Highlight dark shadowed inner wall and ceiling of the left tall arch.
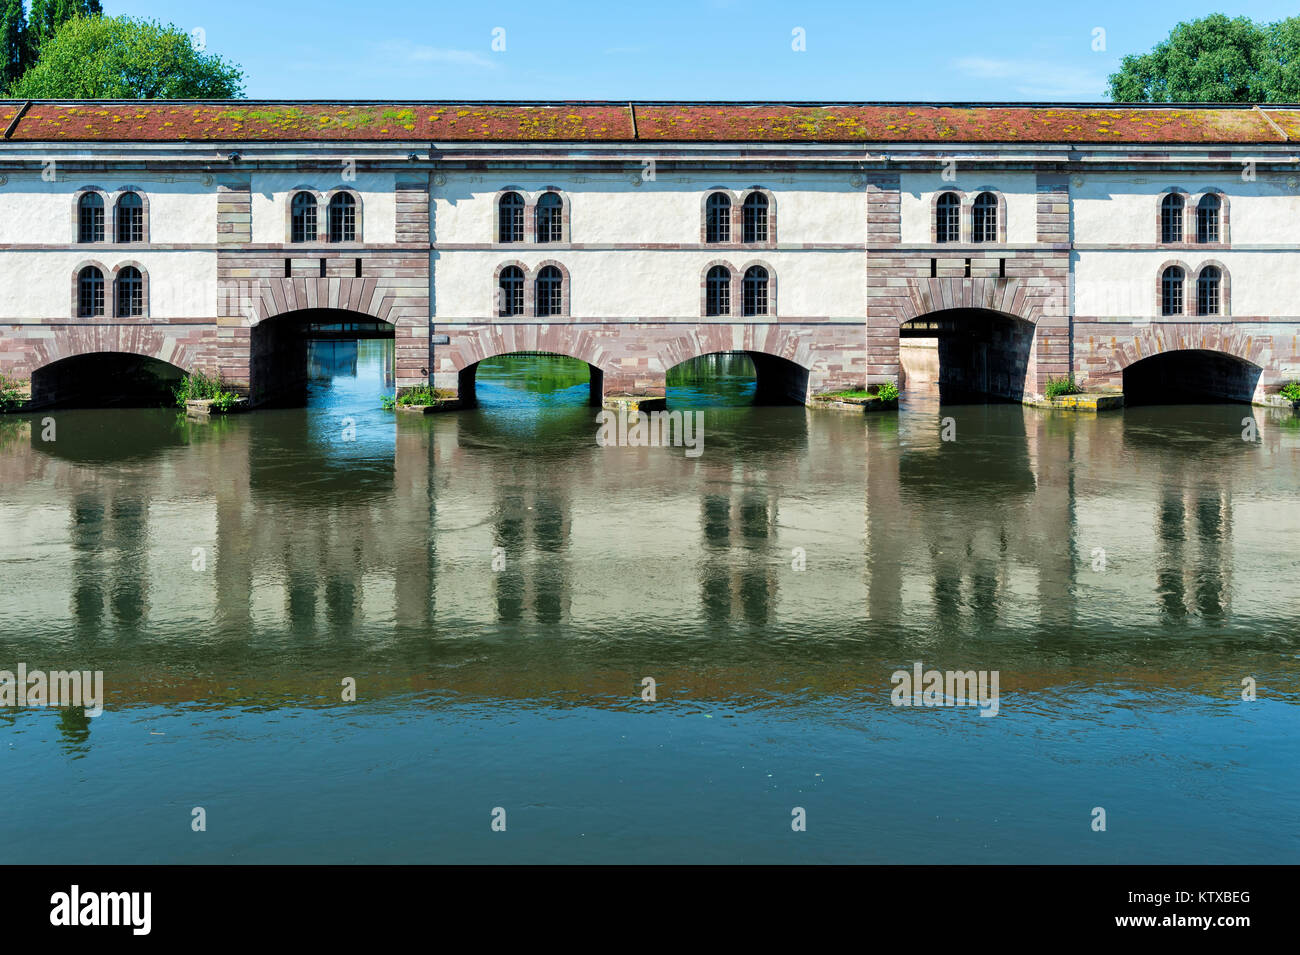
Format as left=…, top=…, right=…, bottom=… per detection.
left=248, top=308, right=397, bottom=405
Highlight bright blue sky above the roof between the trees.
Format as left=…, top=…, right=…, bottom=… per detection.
left=104, top=0, right=1300, bottom=101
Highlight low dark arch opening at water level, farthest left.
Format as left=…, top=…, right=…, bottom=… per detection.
left=30, top=351, right=185, bottom=408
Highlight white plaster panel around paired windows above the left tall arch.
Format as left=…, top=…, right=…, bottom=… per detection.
left=248, top=168, right=395, bottom=244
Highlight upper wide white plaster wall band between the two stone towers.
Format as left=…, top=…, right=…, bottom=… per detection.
left=431, top=170, right=867, bottom=246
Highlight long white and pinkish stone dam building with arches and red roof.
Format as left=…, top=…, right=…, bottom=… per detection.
left=0, top=100, right=1300, bottom=407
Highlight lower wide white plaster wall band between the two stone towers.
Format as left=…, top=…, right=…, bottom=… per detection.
left=434, top=248, right=866, bottom=321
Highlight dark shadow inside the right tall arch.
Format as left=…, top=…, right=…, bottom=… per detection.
left=898, top=308, right=1036, bottom=404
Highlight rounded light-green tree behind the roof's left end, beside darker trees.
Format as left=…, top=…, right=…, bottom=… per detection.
left=10, top=17, right=243, bottom=100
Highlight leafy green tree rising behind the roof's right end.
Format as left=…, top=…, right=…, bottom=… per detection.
left=1110, top=13, right=1300, bottom=103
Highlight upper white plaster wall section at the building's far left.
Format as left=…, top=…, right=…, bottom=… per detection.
left=0, top=173, right=217, bottom=248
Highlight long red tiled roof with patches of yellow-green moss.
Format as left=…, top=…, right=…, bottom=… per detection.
left=0, top=100, right=1300, bottom=144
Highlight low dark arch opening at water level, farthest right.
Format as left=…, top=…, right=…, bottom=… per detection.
left=1123, top=348, right=1264, bottom=404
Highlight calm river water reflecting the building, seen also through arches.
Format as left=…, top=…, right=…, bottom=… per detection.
left=0, top=342, right=1300, bottom=863
